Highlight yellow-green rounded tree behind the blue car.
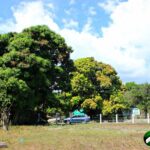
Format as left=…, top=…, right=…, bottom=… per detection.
left=71, top=57, right=122, bottom=115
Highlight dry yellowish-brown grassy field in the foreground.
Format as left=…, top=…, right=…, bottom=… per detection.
left=0, top=123, right=150, bottom=150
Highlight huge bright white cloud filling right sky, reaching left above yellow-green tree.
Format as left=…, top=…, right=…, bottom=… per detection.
left=62, top=0, right=150, bottom=82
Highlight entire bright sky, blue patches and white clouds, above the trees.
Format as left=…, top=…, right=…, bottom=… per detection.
left=0, top=0, right=150, bottom=83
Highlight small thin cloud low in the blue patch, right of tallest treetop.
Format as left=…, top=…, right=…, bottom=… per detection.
left=62, top=19, right=79, bottom=29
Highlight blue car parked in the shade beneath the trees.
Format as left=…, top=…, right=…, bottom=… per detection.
left=64, top=115, right=90, bottom=124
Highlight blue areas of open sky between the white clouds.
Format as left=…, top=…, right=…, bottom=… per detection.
left=0, top=0, right=110, bottom=34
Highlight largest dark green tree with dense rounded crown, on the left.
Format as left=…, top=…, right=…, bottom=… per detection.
left=0, top=26, right=73, bottom=124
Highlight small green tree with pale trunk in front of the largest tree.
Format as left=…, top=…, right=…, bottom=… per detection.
left=0, top=77, right=29, bottom=130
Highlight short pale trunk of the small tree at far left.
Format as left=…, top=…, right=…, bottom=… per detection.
left=2, top=111, right=9, bottom=130
